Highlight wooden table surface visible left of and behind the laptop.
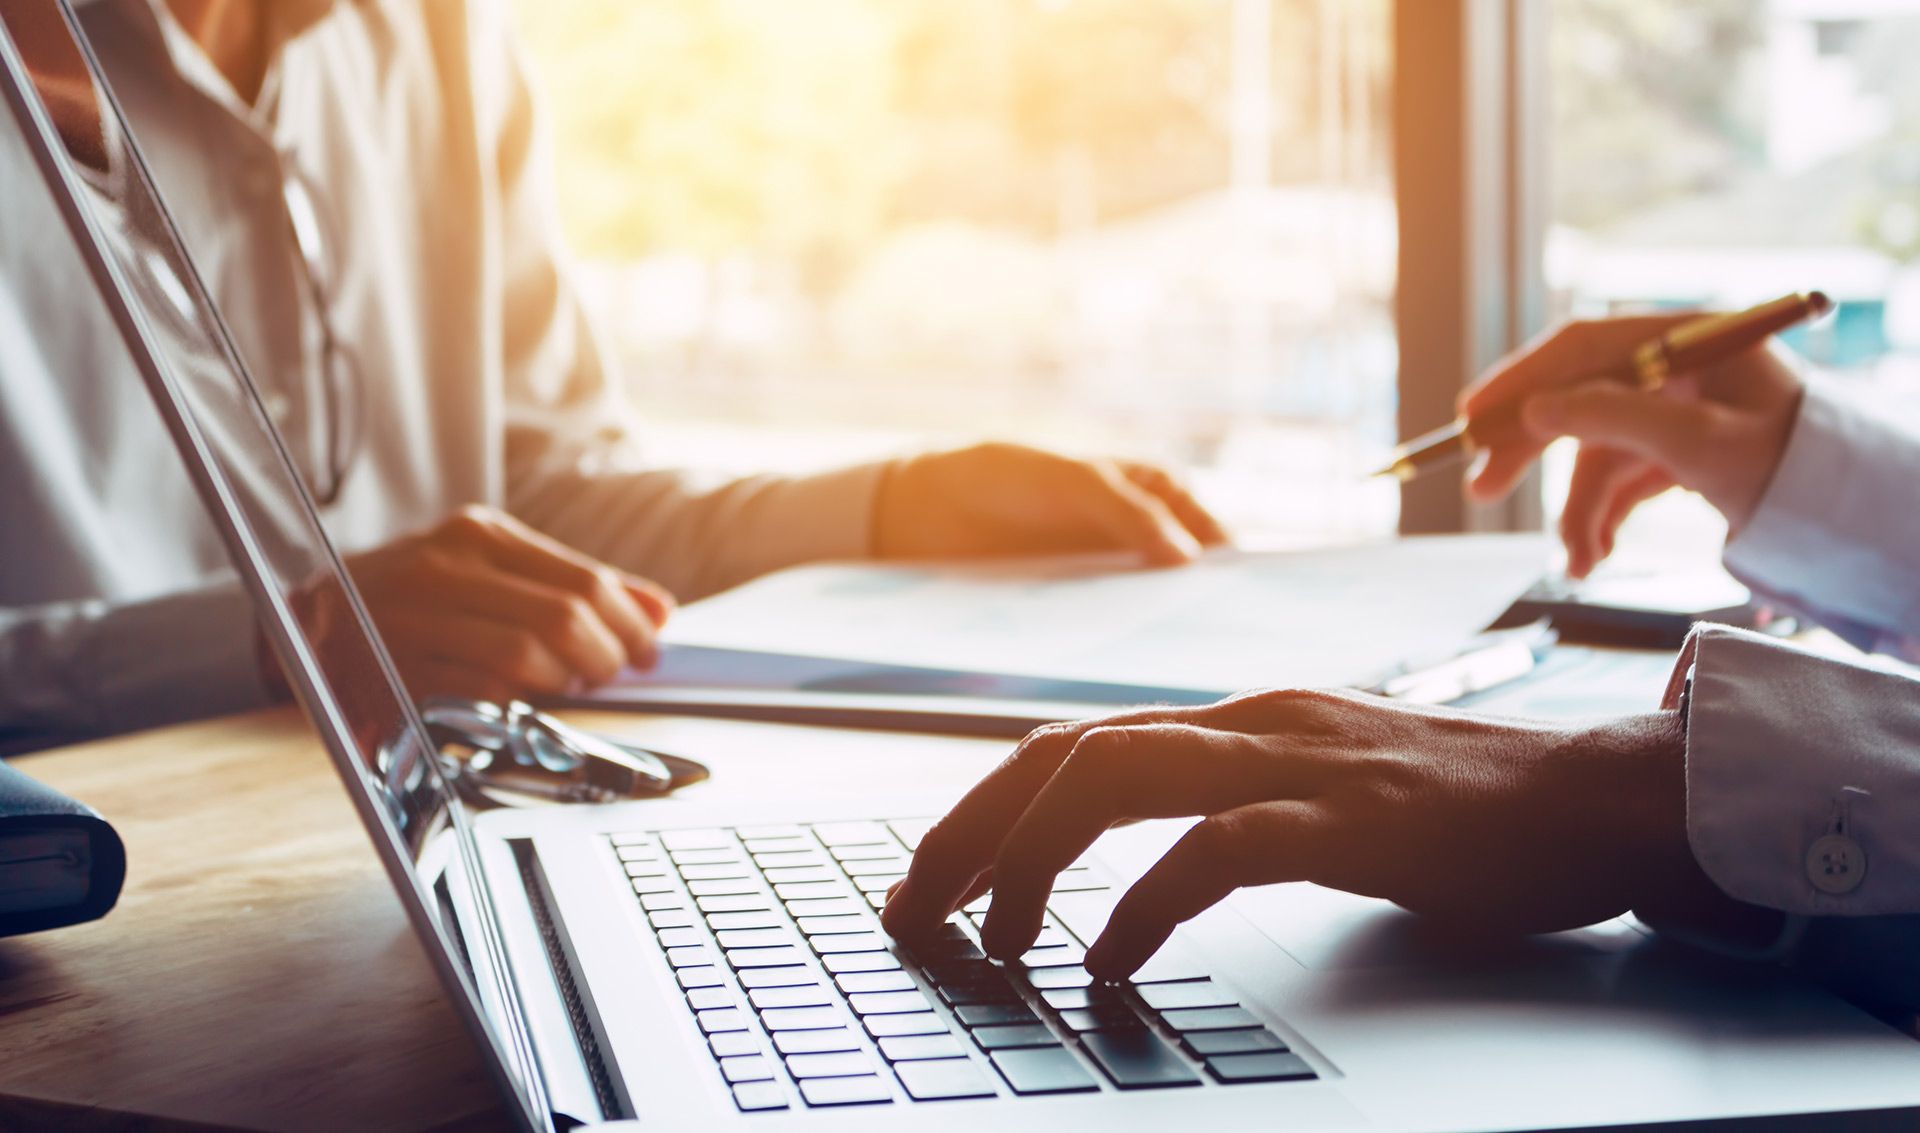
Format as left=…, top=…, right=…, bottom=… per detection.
left=0, top=709, right=1006, bottom=1129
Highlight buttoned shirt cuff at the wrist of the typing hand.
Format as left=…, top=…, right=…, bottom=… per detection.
left=1670, top=626, right=1920, bottom=916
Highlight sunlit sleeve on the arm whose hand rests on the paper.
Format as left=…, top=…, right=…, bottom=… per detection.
left=480, top=8, right=885, bottom=599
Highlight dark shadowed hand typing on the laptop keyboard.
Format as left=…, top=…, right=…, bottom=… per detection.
left=883, top=691, right=1724, bottom=979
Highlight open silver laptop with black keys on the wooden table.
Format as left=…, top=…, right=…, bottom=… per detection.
left=11, top=4, right=1920, bottom=1133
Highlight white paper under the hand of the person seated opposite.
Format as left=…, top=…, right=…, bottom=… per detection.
left=641, top=536, right=1548, bottom=691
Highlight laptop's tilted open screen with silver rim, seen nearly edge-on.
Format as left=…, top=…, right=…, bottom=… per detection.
left=0, top=11, right=553, bottom=1129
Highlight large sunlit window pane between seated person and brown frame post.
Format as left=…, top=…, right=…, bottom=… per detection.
left=518, top=0, right=1398, bottom=538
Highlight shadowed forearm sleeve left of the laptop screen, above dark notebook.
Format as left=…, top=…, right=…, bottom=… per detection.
left=0, top=582, right=271, bottom=753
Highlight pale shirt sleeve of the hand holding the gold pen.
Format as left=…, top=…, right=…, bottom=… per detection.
left=1726, top=386, right=1920, bottom=661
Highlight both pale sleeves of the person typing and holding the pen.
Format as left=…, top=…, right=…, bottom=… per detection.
left=1668, top=388, right=1920, bottom=944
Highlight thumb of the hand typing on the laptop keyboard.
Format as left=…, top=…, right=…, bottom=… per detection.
left=1085, top=799, right=1327, bottom=979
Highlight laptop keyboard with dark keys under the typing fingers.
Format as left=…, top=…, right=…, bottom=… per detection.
left=612, top=820, right=1315, bottom=1112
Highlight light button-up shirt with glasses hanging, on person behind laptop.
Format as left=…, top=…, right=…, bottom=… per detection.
left=0, top=0, right=879, bottom=751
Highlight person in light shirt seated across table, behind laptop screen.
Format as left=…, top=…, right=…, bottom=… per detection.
left=0, top=0, right=1225, bottom=764
